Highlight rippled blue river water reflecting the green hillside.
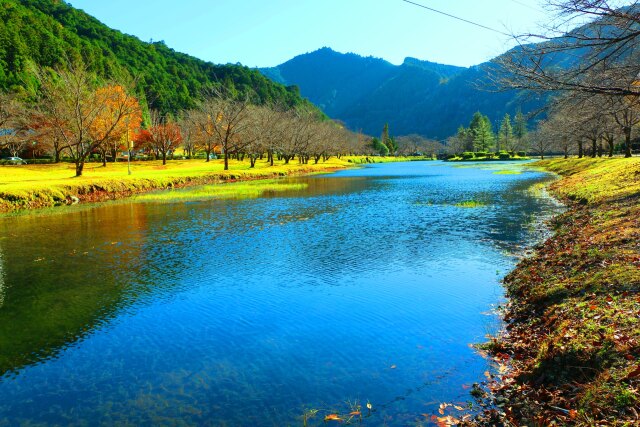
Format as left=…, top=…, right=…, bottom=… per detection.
left=0, top=162, right=555, bottom=426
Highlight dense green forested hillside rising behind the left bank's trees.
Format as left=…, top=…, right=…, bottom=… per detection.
left=0, top=0, right=306, bottom=112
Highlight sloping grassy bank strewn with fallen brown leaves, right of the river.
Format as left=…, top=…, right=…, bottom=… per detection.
left=488, top=158, right=640, bottom=426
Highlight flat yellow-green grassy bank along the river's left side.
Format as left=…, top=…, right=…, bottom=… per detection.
left=0, top=156, right=430, bottom=213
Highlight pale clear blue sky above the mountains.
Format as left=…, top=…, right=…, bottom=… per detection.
left=68, top=0, right=548, bottom=67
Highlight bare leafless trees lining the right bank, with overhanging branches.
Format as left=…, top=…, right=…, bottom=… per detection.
left=496, top=0, right=640, bottom=157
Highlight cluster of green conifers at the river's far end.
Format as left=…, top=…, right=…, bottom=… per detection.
left=447, top=111, right=528, bottom=154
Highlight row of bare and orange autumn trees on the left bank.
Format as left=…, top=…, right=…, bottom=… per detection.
left=0, top=66, right=388, bottom=176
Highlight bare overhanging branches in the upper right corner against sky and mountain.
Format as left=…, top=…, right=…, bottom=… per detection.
left=496, top=0, right=640, bottom=96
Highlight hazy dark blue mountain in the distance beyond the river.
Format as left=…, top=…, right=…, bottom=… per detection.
left=260, top=47, right=544, bottom=139
